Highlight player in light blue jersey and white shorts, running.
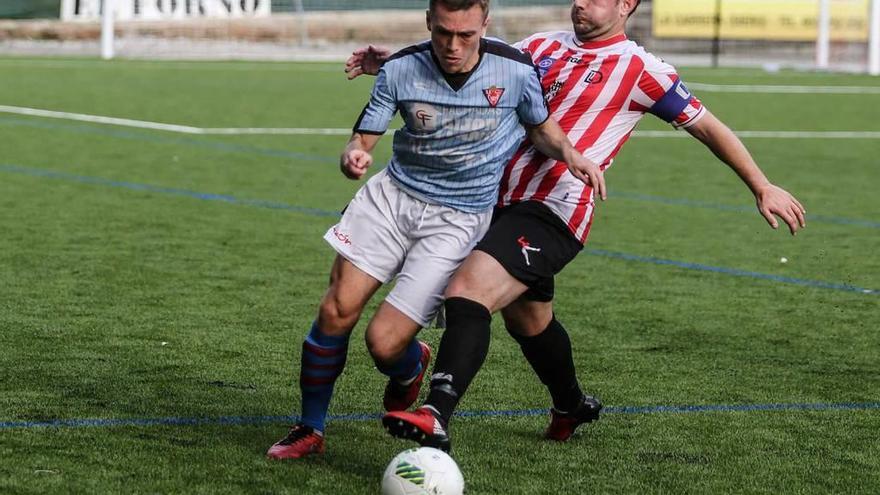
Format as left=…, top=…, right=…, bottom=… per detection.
left=267, top=0, right=605, bottom=459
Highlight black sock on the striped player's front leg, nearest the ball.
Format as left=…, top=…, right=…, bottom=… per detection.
left=425, top=297, right=492, bottom=425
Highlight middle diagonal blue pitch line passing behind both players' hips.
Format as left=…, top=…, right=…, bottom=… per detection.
left=0, top=163, right=880, bottom=295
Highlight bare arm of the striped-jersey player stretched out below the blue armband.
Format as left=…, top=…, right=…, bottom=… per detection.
left=687, top=110, right=807, bottom=235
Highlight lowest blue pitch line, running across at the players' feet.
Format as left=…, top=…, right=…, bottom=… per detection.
left=0, top=402, right=880, bottom=430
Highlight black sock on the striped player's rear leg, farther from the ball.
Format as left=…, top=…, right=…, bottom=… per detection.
left=509, top=315, right=583, bottom=412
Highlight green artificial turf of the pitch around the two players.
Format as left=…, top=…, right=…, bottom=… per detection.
left=0, top=58, right=880, bottom=494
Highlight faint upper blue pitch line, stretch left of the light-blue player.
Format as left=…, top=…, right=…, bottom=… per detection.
left=0, top=117, right=339, bottom=163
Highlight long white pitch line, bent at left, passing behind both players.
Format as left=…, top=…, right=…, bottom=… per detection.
left=0, top=105, right=880, bottom=139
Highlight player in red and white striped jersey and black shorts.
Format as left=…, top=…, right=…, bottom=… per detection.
left=346, top=0, right=805, bottom=449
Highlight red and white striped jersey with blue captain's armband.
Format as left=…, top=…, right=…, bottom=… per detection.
left=498, top=31, right=706, bottom=243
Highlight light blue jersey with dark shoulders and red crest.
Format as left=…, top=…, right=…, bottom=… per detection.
left=354, top=38, right=549, bottom=213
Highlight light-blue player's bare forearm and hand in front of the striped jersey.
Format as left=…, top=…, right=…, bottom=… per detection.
left=525, top=118, right=607, bottom=201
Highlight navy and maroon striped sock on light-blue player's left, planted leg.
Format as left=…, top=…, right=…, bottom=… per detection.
left=299, top=323, right=349, bottom=432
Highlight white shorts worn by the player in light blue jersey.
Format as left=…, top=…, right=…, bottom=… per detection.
left=324, top=170, right=492, bottom=327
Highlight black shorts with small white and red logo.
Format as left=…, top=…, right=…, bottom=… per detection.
left=474, top=201, right=584, bottom=302
